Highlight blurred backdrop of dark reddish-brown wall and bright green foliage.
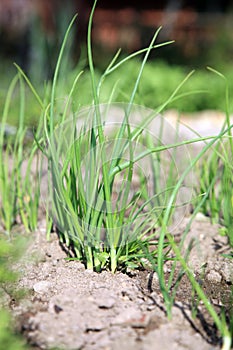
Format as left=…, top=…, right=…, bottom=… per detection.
left=0, top=0, right=233, bottom=125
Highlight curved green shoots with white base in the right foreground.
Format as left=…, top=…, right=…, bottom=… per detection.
left=154, top=116, right=233, bottom=350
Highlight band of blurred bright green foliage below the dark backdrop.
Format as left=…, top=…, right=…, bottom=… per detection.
left=0, top=56, right=233, bottom=126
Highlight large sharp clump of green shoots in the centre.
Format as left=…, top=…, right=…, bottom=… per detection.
left=37, top=2, right=200, bottom=272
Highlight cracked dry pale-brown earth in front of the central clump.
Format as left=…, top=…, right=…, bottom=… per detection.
left=8, top=216, right=233, bottom=350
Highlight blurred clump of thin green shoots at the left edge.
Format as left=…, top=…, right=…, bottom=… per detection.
left=0, top=74, right=40, bottom=234
